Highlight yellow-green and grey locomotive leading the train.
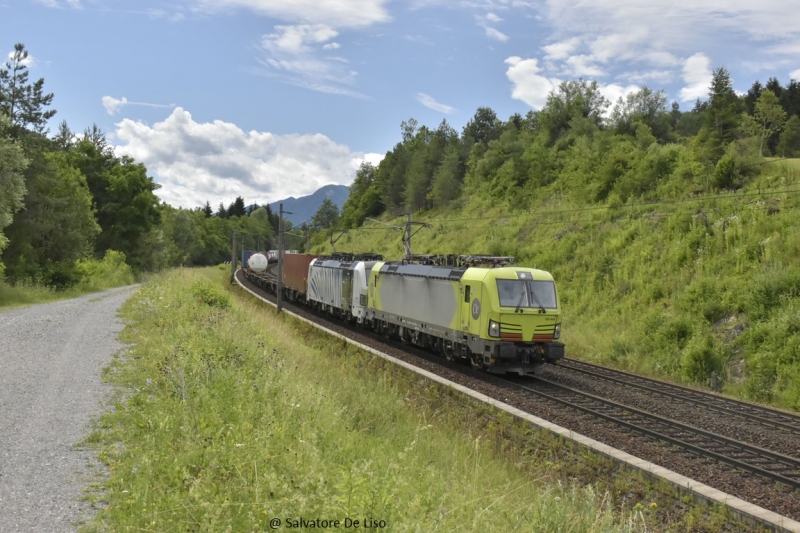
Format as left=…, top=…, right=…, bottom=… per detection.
left=367, top=256, right=564, bottom=375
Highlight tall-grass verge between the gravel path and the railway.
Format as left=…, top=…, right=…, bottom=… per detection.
left=79, top=269, right=752, bottom=532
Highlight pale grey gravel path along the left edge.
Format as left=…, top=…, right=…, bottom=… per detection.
left=0, top=286, right=136, bottom=533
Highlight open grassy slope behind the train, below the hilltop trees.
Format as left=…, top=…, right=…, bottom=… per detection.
left=314, top=160, right=800, bottom=410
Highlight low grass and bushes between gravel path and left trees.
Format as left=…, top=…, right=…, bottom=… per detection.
left=0, top=251, right=137, bottom=309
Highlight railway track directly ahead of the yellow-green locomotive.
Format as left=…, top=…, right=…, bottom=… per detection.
left=507, top=377, right=800, bottom=490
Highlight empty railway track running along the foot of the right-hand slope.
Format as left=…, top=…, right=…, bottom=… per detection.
left=559, top=359, right=800, bottom=435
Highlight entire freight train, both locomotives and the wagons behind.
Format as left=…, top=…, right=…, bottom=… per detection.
left=245, top=253, right=564, bottom=375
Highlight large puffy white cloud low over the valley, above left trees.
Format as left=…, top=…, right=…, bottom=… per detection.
left=115, top=107, right=381, bottom=207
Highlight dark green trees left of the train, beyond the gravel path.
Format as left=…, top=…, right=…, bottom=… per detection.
left=0, top=44, right=304, bottom=288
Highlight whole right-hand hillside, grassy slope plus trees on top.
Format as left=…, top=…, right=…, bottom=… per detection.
left=314, top=68, right=800, bottom=409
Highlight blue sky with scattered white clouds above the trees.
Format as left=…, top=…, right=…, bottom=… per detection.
left=0, top=0, right=800, bottom=208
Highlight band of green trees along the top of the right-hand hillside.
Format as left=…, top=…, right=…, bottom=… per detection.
left=340, top=67, right=800, bottom=227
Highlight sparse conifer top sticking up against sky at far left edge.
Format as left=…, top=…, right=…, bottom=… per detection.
left=0, top=43, right=56, bottom=133
